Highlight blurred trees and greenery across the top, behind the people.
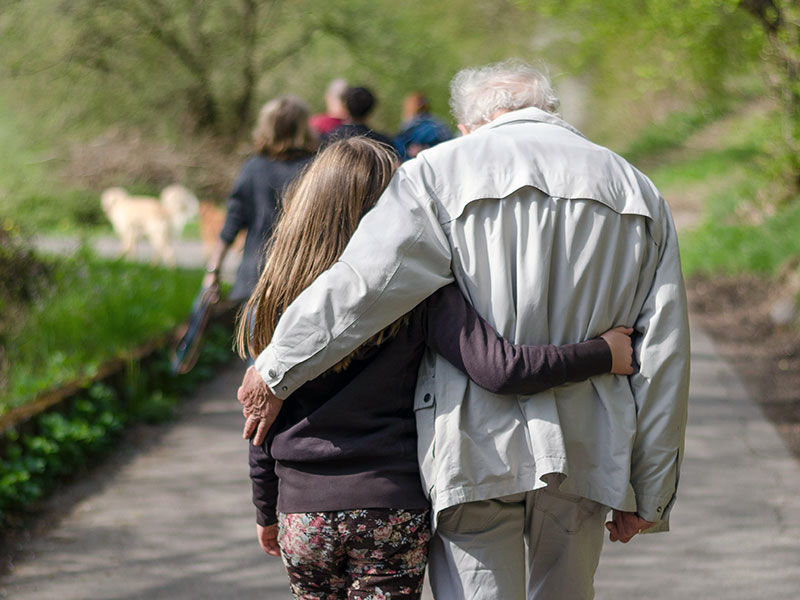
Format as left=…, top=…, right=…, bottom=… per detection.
left=0, top=0, right=800, bottom=207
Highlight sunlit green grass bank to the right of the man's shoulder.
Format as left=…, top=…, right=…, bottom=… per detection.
left=636, top=106, right=800, bottom=277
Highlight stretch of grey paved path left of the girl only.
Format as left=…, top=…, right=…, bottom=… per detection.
left=0, top=365, right=291, bottom=600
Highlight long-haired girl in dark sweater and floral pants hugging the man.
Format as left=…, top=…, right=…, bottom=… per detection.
left=237, top=138, right=632, bottom=599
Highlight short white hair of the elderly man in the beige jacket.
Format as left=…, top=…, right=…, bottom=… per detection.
left=450, top=59, right=559, bottom=130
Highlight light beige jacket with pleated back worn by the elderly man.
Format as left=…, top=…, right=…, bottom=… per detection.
left=256, top=108, right=689, bottom=530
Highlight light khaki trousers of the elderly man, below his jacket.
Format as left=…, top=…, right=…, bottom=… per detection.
left=429, top=486, right=609, bottom=600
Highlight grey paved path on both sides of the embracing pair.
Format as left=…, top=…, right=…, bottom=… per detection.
left=0, top=318, right=800, bottom=600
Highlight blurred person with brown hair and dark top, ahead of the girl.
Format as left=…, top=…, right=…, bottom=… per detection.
left=203, top=96, right=317, bottom=301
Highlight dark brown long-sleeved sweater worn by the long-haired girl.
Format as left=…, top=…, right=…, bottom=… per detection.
left=250, top=284, right=611, bottom=525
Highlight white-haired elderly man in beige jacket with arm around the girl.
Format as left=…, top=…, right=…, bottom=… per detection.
left=239, top=57, right=689, bottom=600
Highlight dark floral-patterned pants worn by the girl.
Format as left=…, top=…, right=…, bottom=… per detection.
left=278, top=508, right=430, bottom=600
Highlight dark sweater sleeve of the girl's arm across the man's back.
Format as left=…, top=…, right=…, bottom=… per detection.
left=425, top=284, right=611, bottom=394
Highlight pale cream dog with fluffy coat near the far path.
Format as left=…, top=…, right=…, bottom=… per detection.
left=101, top=184, right=198, bottom=266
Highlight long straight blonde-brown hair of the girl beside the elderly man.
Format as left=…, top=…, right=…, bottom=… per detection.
left=235, top=137, right=407, bottom=370
